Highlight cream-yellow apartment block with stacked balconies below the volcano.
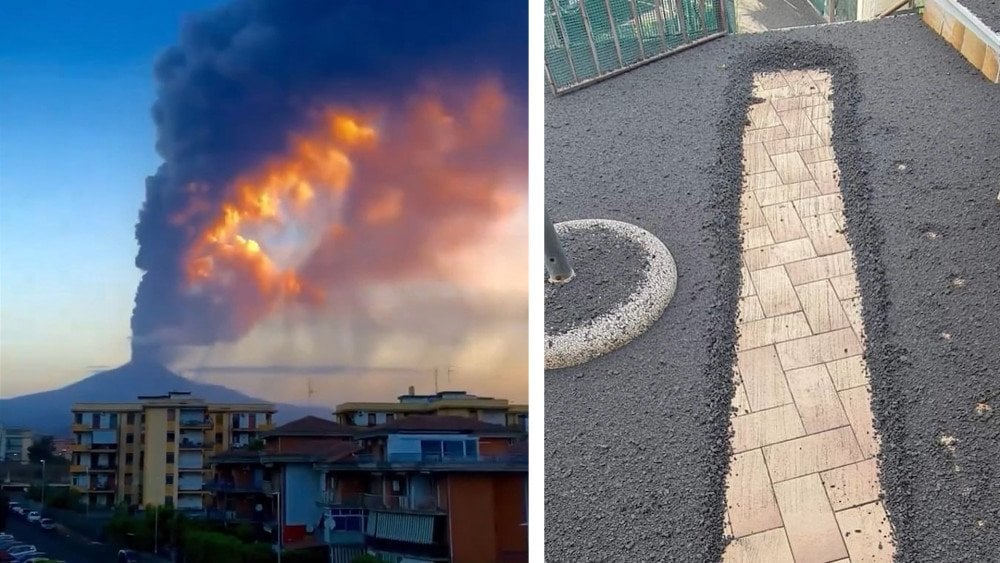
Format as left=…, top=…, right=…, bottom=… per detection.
left=70, top=391, right=275, bottom=510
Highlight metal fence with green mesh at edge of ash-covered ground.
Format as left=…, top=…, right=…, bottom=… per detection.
left=545, top=0, right=730, bottom=94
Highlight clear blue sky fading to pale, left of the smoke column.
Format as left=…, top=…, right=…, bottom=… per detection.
left=0, top=0, right=220, bottom=397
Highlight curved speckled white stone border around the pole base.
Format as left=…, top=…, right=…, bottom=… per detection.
left=545, top=219, right=677, bottom=369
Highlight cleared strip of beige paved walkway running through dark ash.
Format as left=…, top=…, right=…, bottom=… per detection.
left=724, top=71, right=893, bottom=563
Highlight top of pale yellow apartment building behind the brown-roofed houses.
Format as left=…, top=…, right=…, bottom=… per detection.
left=334, top=387, right=528, bottom=431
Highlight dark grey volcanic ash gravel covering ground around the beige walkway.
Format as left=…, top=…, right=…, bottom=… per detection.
left=545, top=16, right=1000, bottom=561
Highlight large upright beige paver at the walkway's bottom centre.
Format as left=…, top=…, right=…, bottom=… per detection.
left=774, top=474, right=847, bottom=563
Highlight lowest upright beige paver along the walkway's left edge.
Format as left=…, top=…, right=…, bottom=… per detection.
left=726, top=450, right=781, bottom=537
